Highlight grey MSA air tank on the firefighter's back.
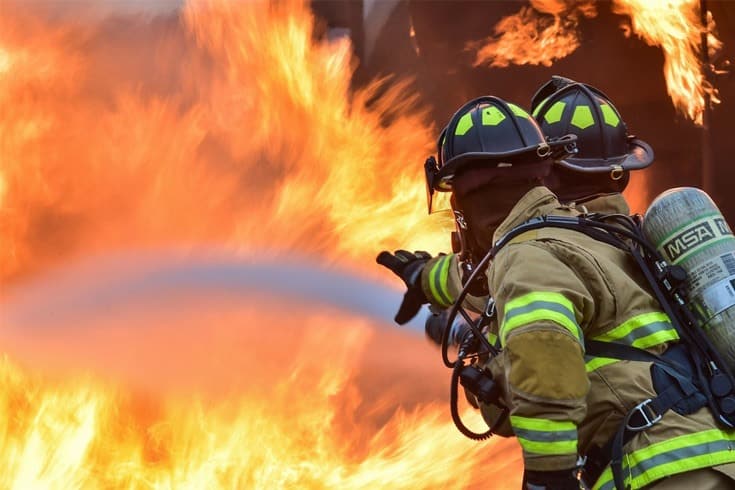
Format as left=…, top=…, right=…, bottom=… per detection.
left=642, top=187, right=735, bottom=370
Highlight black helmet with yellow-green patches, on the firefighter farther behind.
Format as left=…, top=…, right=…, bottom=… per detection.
left=532, top=77, right=653, bottom=173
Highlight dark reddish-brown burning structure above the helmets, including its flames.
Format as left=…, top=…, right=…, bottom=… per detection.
left=315, top=0, right=735, bottom=214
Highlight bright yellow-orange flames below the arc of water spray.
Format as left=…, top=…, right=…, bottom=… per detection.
left=0, top=296, right=520, bottom=489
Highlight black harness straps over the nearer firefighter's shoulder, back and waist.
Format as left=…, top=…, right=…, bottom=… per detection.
left=488, top=215, right=735, bottom=490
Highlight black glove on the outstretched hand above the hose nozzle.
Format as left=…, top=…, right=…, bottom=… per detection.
left=376, top=250, right=431, bottom=325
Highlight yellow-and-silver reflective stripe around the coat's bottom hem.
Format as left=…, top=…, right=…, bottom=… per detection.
left=593, top=429, right=735, bottom=490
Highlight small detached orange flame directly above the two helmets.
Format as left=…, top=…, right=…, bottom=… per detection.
left=469, top=0, right=597, bottom=68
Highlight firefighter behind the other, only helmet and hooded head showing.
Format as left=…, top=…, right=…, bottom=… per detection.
left=531, top=76, right=653, bottom=214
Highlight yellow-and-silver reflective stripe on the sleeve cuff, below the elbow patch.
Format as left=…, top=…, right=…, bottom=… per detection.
left=510, top=415, right=577, bottom=456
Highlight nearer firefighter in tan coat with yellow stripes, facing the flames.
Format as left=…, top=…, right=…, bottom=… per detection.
left=378, top=97, right=735, bottom=490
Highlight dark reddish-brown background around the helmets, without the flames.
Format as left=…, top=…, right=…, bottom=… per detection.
left=312, top=0, right=735, bottom=220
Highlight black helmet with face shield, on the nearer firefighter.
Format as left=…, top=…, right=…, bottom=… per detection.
left=426, top=96, right=576, bottom=195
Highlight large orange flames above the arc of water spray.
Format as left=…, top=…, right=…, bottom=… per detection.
left=0, top=0, right=451, bottom=279
